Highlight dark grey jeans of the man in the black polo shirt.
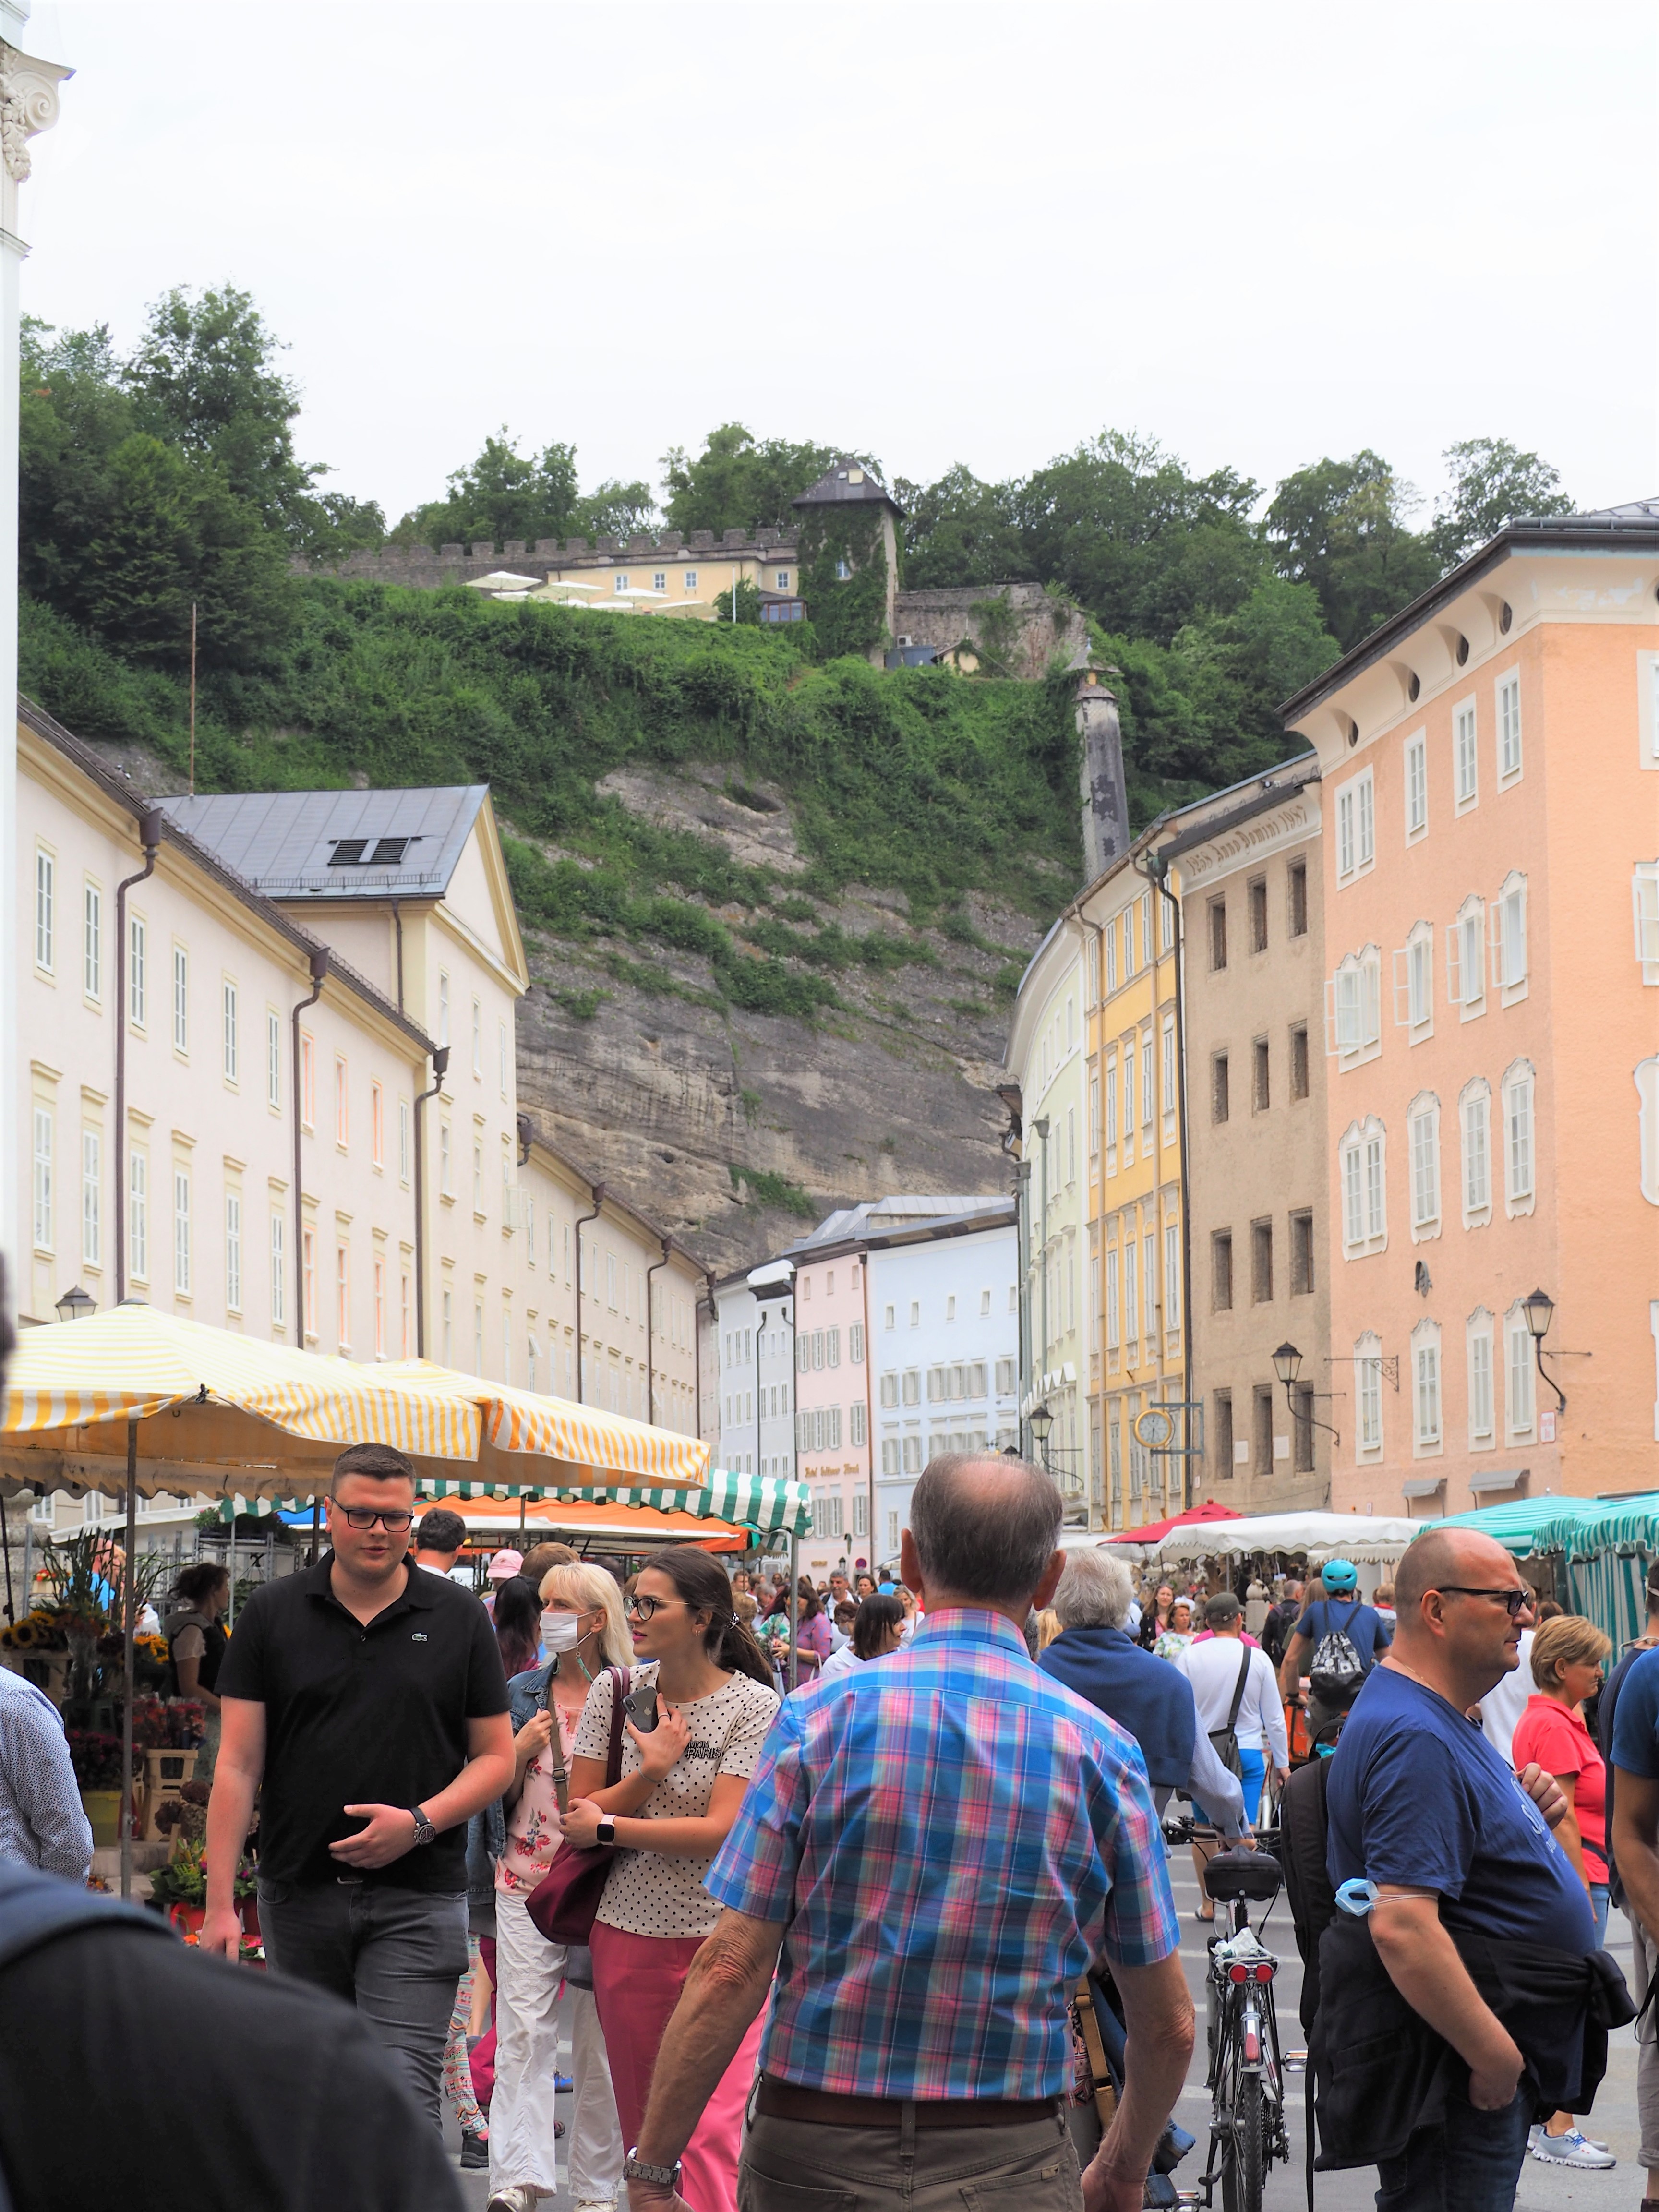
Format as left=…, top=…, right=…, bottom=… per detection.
left=259, top=1882, right=467, bottom=2128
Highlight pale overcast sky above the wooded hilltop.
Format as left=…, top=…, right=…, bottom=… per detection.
left=22, top=0, right=1659, bottom=517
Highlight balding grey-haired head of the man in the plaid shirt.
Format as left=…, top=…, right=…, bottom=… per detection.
left=909, top=1451, right=1059, bottom=1606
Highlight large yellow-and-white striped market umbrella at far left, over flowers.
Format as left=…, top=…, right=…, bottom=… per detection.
left=0, top=1305, right=482, bottom=1495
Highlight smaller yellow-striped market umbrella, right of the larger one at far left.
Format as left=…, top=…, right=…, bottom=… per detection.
left=376, top=1360, right=710, bottom=1491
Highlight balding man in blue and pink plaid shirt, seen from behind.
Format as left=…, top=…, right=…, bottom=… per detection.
left=624, top=1458, right=1192, bottom=2212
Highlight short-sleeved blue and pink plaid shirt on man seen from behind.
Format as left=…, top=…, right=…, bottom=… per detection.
left=703, top=1608, right=1179, bottom=2099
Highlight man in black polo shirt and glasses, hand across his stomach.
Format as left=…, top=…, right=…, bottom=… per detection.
left=201, top=1444, right=513, bottom=2126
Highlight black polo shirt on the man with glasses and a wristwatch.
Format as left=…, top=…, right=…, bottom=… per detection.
left=219, top=1553, right=506, bottom=1891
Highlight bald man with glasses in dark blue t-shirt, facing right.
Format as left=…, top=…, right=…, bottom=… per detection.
left=1321, top=1528, right=1595, bottom=2212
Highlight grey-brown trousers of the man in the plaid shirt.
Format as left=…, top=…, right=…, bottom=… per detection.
left=736, top=2113, right=1084, bottom=2212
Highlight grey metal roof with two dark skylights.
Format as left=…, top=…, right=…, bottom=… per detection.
left=157, top=783, right=489, bottom=898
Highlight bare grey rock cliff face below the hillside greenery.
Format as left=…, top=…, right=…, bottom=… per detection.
left=517, top=768, right=1059, bottom=1270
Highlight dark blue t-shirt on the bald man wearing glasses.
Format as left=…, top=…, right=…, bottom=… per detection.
left=1325, top=1655, right=1601, bottom=1958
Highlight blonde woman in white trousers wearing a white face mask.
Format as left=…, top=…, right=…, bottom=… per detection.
left=489, top=1564, right=633, bottom=2212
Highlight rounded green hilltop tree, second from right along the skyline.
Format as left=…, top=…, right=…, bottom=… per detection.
left=1263, top=447, right=1440, bottom=652
